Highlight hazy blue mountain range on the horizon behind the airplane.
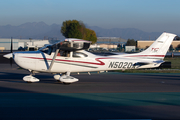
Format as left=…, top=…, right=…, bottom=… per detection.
left=0, top=22, right=163, bottom=40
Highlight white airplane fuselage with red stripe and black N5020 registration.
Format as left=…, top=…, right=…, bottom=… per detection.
left=14, top=50, right=160, bottom=73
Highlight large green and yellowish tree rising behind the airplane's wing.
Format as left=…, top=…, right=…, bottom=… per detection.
left=61, top=20, right=97, bottom=43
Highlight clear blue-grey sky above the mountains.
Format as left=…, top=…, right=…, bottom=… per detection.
left=0, top=0, right=180, bottom=34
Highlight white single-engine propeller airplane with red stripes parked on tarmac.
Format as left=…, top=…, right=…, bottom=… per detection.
left=4, top=32, right=176, bottom=84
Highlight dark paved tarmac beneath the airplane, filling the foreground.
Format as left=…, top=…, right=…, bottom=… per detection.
left=0, top=64, right=180, bottom=120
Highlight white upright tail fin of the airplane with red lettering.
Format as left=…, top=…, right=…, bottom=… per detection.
left=134, top=32, right=176, bottom=60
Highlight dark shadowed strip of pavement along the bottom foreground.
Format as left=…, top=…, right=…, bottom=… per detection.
left=0, top=87, right=178, bottom=120
